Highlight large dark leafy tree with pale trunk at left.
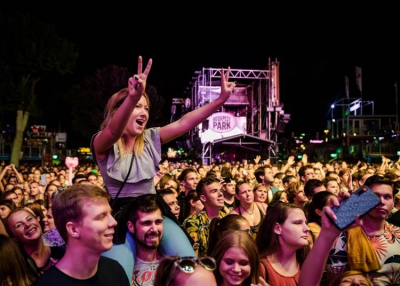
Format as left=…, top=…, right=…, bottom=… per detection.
left=0, top=13, right=78, bottom=166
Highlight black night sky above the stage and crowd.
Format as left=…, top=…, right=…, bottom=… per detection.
left=32, top=8, right=400, bottom=138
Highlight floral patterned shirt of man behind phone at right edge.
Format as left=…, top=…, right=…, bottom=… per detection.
left=326, top=222, right=400, bottom=285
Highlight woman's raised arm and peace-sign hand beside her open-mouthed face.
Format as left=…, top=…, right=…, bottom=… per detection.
left=93, top=56, right=152, bottom=156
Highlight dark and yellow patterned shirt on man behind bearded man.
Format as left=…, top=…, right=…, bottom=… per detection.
left=183, top=210, right=226, bottom=256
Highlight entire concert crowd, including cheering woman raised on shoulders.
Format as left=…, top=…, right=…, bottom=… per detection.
left=0, top=57, right=400, bottom=286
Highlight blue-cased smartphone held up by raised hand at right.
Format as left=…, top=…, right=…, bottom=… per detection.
left=331, top=186, right=381, bottom=230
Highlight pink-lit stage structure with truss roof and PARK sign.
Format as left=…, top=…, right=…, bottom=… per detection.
left=171, top=59, right=290, bottom=164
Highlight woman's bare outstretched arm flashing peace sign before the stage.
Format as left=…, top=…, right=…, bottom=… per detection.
left=160, top=67, right=236, bottom=144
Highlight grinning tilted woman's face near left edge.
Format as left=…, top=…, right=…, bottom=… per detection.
left=7, top=209, right=42, bottom=244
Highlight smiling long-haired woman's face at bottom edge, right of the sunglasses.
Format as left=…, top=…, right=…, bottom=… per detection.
left=219, top=247, right=251, bottom=285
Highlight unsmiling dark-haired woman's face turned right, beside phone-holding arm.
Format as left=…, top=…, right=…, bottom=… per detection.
left=274, top=208, right=310, bottom=250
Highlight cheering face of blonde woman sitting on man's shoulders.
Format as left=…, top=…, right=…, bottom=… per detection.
left=125, top=96, right=149, bottom=136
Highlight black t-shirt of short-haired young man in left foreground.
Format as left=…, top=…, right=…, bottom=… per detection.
left=32, top=256, right=129, bottom=286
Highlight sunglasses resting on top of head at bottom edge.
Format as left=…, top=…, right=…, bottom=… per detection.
left=165, top=257, right=217, bottom=285
